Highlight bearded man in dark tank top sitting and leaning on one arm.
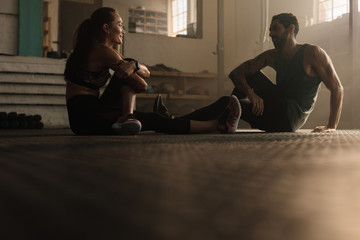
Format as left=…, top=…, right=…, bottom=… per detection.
left=229, top=13, right=344, bottom=132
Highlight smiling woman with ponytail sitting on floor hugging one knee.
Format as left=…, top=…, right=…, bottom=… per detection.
left=65, top=7, right=241, bottom=135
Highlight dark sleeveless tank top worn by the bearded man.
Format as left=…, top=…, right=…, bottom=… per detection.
left=275, top=44, right=321, bottom=131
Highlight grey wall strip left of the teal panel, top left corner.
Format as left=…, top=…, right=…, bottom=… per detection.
left=0, top=0, right=19, bottom=55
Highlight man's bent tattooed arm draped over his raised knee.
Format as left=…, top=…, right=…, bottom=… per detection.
left=229, top=49, right=277, bottom=116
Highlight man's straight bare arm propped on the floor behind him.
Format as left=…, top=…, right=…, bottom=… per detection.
left=310, top=46, right=344, bottom=132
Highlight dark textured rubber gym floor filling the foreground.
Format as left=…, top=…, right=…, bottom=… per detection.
left=0, top=129, right=360, bottom=240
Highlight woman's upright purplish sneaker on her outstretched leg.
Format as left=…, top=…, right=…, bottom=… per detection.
left=219, top=95, right=241, bottom=133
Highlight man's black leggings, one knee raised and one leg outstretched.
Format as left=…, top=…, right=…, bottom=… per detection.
left=183, top=72, right=292, bottom=132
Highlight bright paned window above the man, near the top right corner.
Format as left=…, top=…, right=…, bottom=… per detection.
left=317, top=0, right=360, bottom=23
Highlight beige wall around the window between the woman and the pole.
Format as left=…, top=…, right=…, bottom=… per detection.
left=103, top=0, right=217, bottom=73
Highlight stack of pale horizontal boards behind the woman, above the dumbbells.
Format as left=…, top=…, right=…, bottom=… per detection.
left=0, top=56, right=68, bottom=128
